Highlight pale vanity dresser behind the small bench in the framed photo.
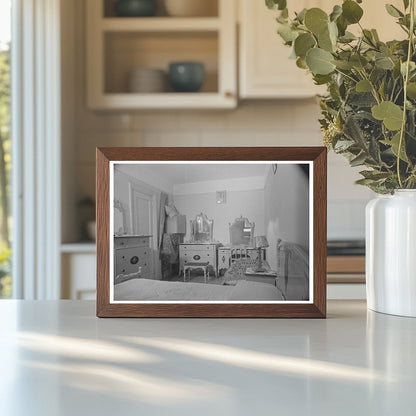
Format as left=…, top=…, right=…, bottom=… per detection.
left=179, top=243, right=221, bottom=276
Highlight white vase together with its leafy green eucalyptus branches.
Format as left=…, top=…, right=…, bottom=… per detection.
left=266, top=0, right=416, bottom=316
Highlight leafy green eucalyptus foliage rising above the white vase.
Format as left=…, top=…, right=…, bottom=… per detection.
left=266, top=0, right=416, bottom=194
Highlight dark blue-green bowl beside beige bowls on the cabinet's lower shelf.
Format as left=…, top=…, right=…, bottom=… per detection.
left=169, top=62, right=205, bottom=92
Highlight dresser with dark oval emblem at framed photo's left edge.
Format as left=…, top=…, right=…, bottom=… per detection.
left=114, top=235, right=153, bottom=279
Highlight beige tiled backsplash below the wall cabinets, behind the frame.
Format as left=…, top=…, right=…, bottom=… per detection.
left=72, top=100, right=372, bottom=239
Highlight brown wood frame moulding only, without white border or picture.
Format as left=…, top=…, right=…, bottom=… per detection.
left=96, top=147, right=327, bottom=318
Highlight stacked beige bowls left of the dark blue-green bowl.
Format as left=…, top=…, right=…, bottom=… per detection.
left=128, top=68, right=168, bottom=94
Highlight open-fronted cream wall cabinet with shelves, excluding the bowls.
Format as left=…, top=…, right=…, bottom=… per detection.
left=86, top=0, right=237, bottom=110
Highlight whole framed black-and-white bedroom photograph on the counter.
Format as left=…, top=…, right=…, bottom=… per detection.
left=96, top=147, right=327, bottom=318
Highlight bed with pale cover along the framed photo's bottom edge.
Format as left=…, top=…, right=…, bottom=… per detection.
left=114, top=279, right=284, bottom=301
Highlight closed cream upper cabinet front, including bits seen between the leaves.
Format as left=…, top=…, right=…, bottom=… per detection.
left=238, top=0, right=404, bottom=99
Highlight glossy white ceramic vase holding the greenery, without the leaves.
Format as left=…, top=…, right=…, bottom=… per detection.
left=366, top=190, right=416, bottom=317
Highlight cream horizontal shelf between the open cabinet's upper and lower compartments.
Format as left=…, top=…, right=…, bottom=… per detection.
left=100, top=17, right=221, bottom=32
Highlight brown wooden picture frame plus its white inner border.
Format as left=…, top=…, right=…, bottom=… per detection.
left=96, top=147, right=327, bottom=318
